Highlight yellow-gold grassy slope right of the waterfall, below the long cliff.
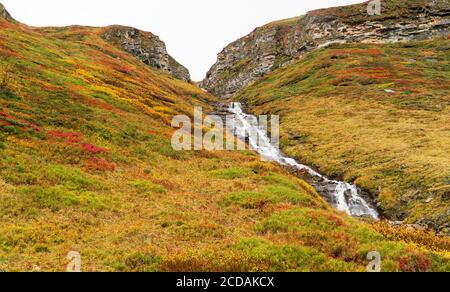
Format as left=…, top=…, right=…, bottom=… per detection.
left=238, top=39, right=450, bottom=233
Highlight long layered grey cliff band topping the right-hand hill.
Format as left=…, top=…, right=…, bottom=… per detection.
left=201, top=0, right=450, bottom=97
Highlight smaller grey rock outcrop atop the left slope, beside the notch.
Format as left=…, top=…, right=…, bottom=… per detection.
left=103, top=26, right=191, bottom=82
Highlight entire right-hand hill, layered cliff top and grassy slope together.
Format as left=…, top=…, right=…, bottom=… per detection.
left=201, top=0, right=450, bottom=234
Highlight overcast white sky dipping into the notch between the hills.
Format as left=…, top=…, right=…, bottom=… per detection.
left=0, top=0, right=364, bottom=80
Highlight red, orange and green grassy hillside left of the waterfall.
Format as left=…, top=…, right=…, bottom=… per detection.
left=0, top=19, right=450, bottom=271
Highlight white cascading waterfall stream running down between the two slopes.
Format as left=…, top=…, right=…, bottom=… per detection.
left=227, top=103, right=379, bottom=219
